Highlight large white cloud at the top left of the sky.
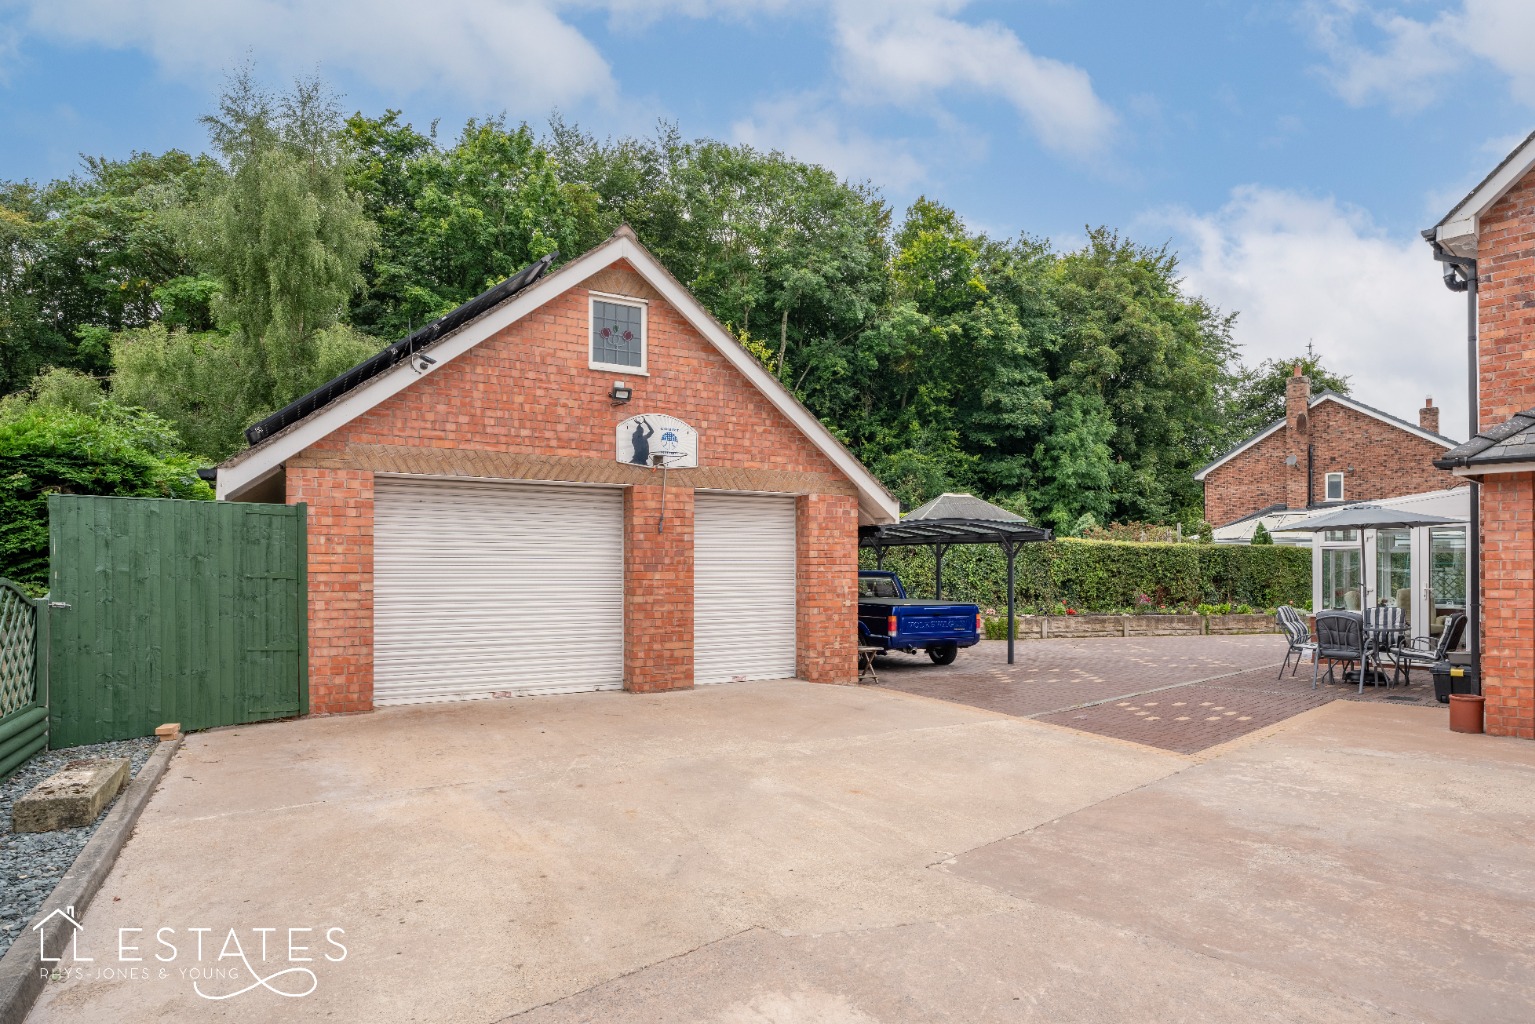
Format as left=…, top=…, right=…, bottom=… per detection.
left=16, top=0, right=614, bottom=109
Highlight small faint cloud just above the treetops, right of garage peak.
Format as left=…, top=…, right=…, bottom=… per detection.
left=731, top=95, right=927, bottom=192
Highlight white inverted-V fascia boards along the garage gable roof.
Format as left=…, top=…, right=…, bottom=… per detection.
left=218, top=226, right=901, bottom=524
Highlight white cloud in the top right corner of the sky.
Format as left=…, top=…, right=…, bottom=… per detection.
left=1305, top=0, right=1535, bottom=109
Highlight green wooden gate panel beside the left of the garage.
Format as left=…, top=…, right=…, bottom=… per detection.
left=48, top=494, right=309, bottom=749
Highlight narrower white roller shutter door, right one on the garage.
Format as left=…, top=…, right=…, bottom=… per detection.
left=692, top=491, right=795, bottom=683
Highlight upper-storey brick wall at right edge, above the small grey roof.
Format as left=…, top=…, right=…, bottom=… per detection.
left=1477, top=172, right=1535, bottom=427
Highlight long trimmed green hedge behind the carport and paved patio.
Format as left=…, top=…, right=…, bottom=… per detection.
left=860, top=539, right=1311, bottom=611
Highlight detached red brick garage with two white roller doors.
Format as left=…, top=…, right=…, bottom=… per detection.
left=216, top=227, right=900, bottom=712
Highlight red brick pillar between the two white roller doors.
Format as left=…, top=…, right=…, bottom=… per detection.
left=623, top=487, right=696, bottom=694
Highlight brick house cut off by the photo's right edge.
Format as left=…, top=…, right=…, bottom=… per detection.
left=1424, top=135, right=1535, bottom=738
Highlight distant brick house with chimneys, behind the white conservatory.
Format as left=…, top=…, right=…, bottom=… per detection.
left=1194, top=367, right=1461, bottom=527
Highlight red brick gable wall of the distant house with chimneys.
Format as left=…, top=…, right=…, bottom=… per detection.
left=1205, top=402, right=1464, bottom=527
